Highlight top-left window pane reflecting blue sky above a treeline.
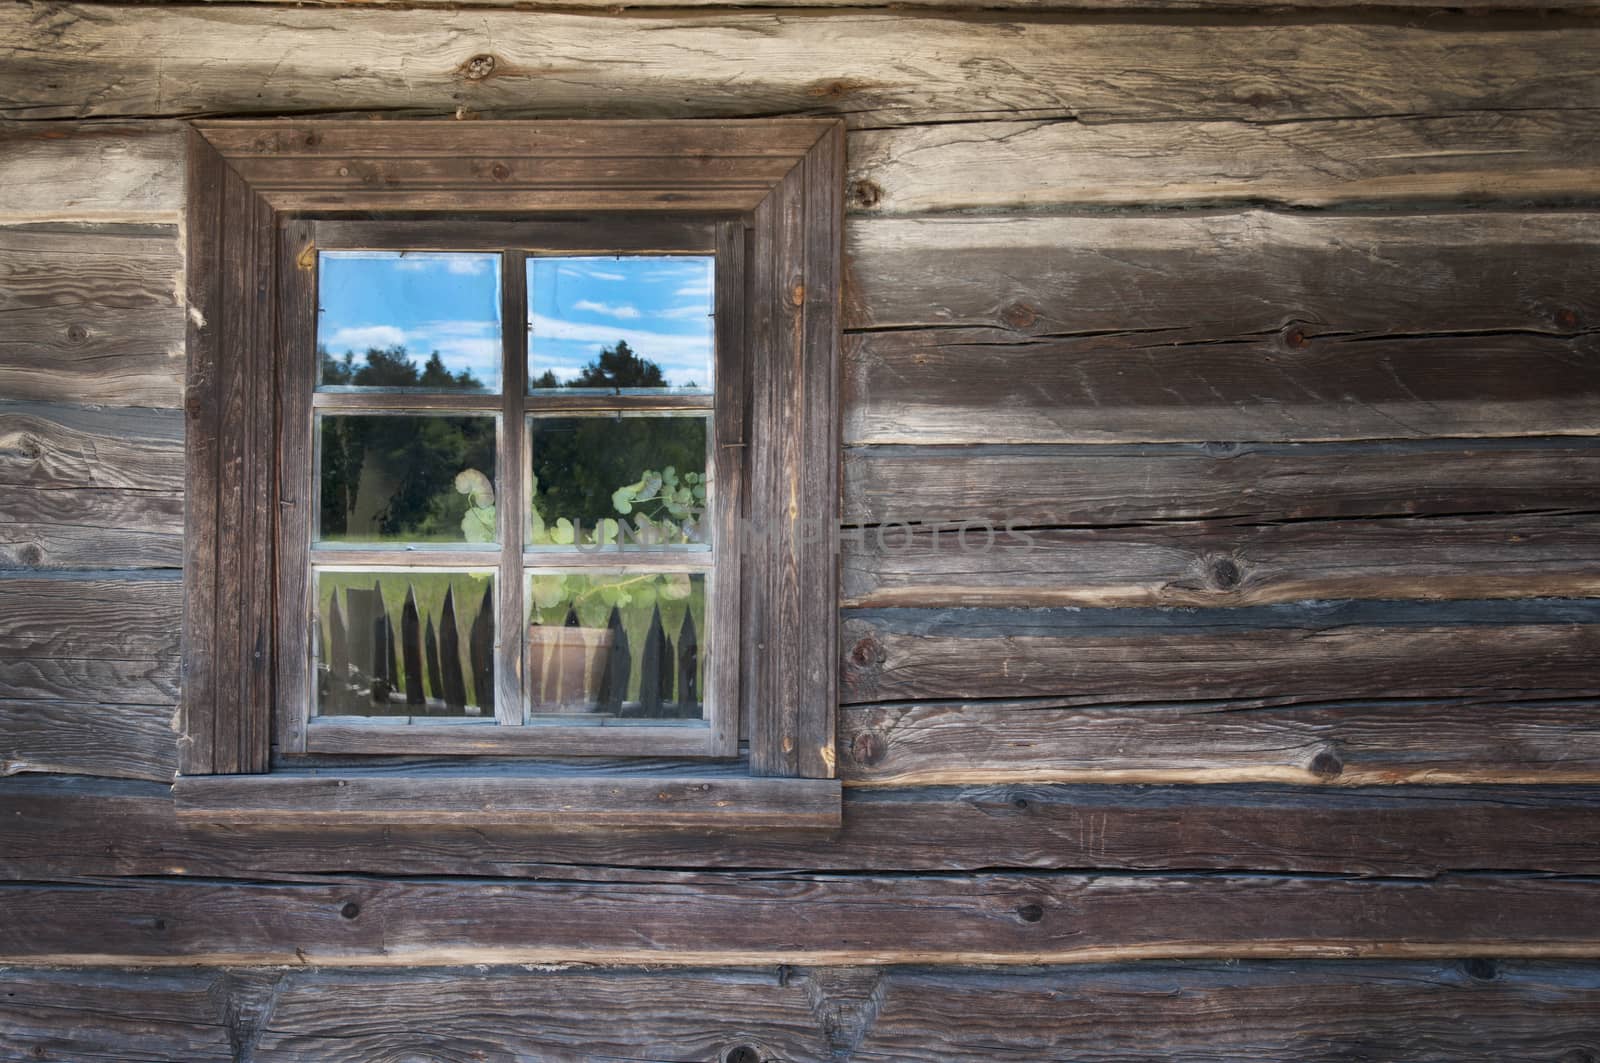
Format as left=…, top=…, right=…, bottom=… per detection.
left=317, top=251, right=501, bottom=391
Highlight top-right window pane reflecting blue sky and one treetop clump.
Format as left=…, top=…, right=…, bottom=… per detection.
left=528, top=255, right=715, bottom=391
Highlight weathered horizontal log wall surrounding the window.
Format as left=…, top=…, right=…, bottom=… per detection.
left=0, top=0, right=1600, bottom=1063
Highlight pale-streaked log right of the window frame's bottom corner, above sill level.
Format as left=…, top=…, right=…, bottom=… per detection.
left=838, top=694, right=1600, bottom=786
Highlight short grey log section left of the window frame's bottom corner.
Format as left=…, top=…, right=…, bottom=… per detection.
left=0, top=697, right=178, bottom=783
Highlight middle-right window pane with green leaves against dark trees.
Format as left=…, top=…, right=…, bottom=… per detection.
left=526, top=415, right=710, bottom=549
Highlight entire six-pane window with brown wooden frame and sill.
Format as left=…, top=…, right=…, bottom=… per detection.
left=176, top=122, right=842, bottom=826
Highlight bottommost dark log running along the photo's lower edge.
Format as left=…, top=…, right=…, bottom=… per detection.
left=12, top=959, right=1600, bottom=1063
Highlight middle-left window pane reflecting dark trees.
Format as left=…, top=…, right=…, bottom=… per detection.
left=317, top=413, right=498, bottom=544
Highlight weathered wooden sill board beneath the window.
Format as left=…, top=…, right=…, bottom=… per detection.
left=173, top=773, right=840, bottom=831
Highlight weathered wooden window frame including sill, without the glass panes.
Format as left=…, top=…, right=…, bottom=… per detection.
left=174, top=120, right=843, bottom=828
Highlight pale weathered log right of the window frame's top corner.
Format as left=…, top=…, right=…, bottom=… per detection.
left=850, top=110, right=1600, bottom=215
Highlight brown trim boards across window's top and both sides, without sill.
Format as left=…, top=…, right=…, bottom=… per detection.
left=179, top=118, right=843, bottom=800
